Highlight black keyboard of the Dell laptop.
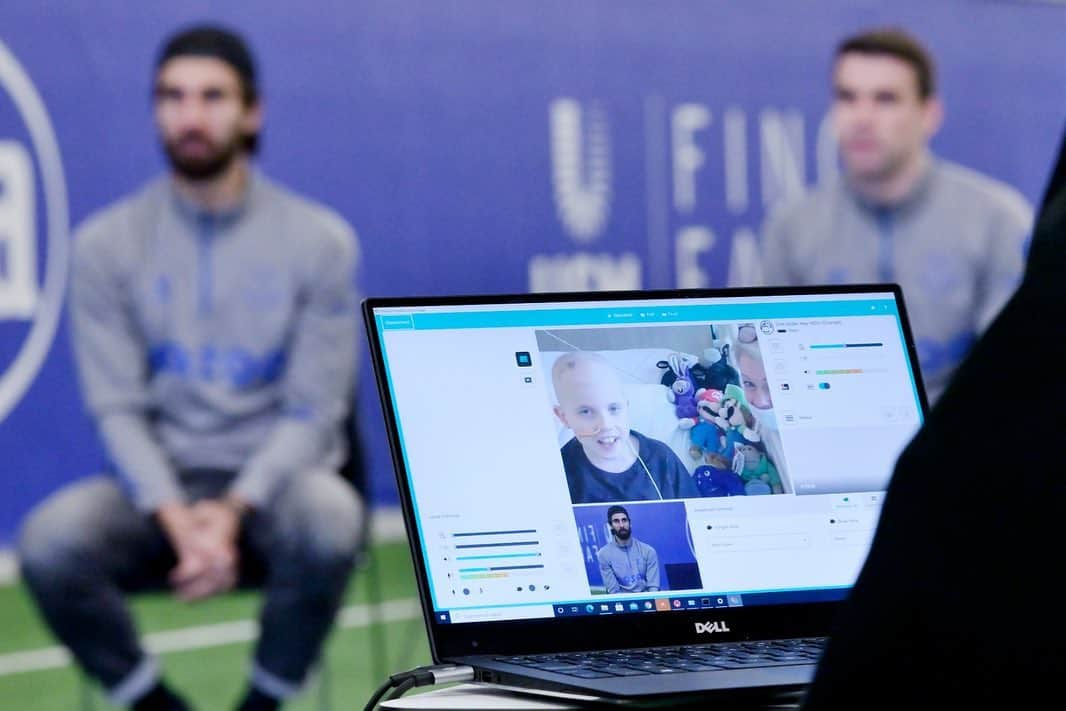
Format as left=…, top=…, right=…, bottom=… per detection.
left=496, top=637, right=826, bottom=679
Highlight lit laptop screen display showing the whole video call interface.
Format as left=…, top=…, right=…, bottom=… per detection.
left=375, top=293, right=921, bottom=624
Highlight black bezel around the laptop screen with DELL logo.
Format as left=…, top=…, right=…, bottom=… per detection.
left=362, top=284, right=928, bottom=662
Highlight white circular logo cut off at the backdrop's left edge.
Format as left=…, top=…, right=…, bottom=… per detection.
left=0, top=42, right=69, bottom=422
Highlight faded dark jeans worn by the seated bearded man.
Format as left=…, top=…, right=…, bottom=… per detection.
left=18, top=470, right=365, bottom=702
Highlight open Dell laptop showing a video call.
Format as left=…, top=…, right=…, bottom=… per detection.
left=364, top=285, right=926, bottom=705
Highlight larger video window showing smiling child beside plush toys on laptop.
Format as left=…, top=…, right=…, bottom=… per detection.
left=536, top=323, right=792, bottom=504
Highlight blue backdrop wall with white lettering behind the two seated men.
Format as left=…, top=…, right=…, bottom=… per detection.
left=0, top=0, right=1066, bottom=545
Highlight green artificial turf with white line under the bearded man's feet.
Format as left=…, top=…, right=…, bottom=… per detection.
left=0, top=542, right=430, bottom=711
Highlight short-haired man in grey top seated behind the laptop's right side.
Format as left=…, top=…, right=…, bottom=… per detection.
left=762, top=29, right=1032, bottom=401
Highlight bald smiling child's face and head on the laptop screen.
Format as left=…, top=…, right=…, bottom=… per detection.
left=555, top=361, right=634, bottom=468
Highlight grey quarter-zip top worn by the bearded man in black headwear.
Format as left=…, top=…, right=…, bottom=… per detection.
left=70, top=172, right=358, bottom=511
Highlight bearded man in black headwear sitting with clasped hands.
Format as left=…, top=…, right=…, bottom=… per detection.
left=19, top=26, right=364, bottom=711
